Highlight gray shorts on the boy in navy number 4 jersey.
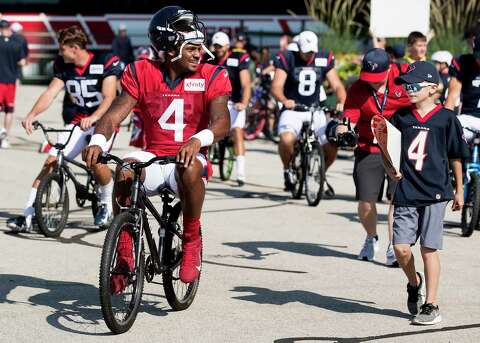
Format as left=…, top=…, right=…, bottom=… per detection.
left=393, top=201, right=447, bottom=250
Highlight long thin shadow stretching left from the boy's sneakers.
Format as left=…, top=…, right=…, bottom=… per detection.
left=232, top=286, right=410, bottom=318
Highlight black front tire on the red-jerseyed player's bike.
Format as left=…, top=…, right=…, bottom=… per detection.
left=99, top=212, right=145, bottom=334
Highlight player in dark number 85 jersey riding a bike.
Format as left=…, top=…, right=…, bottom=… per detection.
left=7, top=26, right=121, bottom=231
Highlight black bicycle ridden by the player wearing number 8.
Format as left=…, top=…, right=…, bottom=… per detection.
left=290, top=104, right=326, bottom=206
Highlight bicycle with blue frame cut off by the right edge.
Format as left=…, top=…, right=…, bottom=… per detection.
left=461, top=127, right=480, bottom=237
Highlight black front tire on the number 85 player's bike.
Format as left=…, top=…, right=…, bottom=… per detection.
left=34, top=173, right=70, bottom=238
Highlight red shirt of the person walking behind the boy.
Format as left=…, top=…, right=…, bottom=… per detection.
left=344, top=64, right=410, bottom=153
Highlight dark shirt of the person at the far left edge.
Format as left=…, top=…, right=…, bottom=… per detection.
left=0, top=36, right=25, bottom=83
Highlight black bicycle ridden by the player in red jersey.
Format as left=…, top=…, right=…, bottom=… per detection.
left=99, top=153, right=199, bottom=334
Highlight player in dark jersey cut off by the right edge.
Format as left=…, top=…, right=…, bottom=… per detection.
left=445, top=32, right=480, bottom=142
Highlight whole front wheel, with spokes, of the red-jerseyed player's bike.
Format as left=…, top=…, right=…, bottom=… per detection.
left=99, top=212, right=145, bottom=334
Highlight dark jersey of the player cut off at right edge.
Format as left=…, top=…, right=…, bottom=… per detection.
left=449, top=54, right=480, bottom=117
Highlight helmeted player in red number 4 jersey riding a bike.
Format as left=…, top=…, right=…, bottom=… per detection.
left=83, top=6, right=231, bottom=287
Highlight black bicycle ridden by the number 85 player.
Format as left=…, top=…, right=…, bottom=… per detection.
left=32, top=121, right=100, bottom=237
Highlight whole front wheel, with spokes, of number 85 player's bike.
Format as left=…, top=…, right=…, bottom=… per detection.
left=35, top=173, right=70, bottom=237
